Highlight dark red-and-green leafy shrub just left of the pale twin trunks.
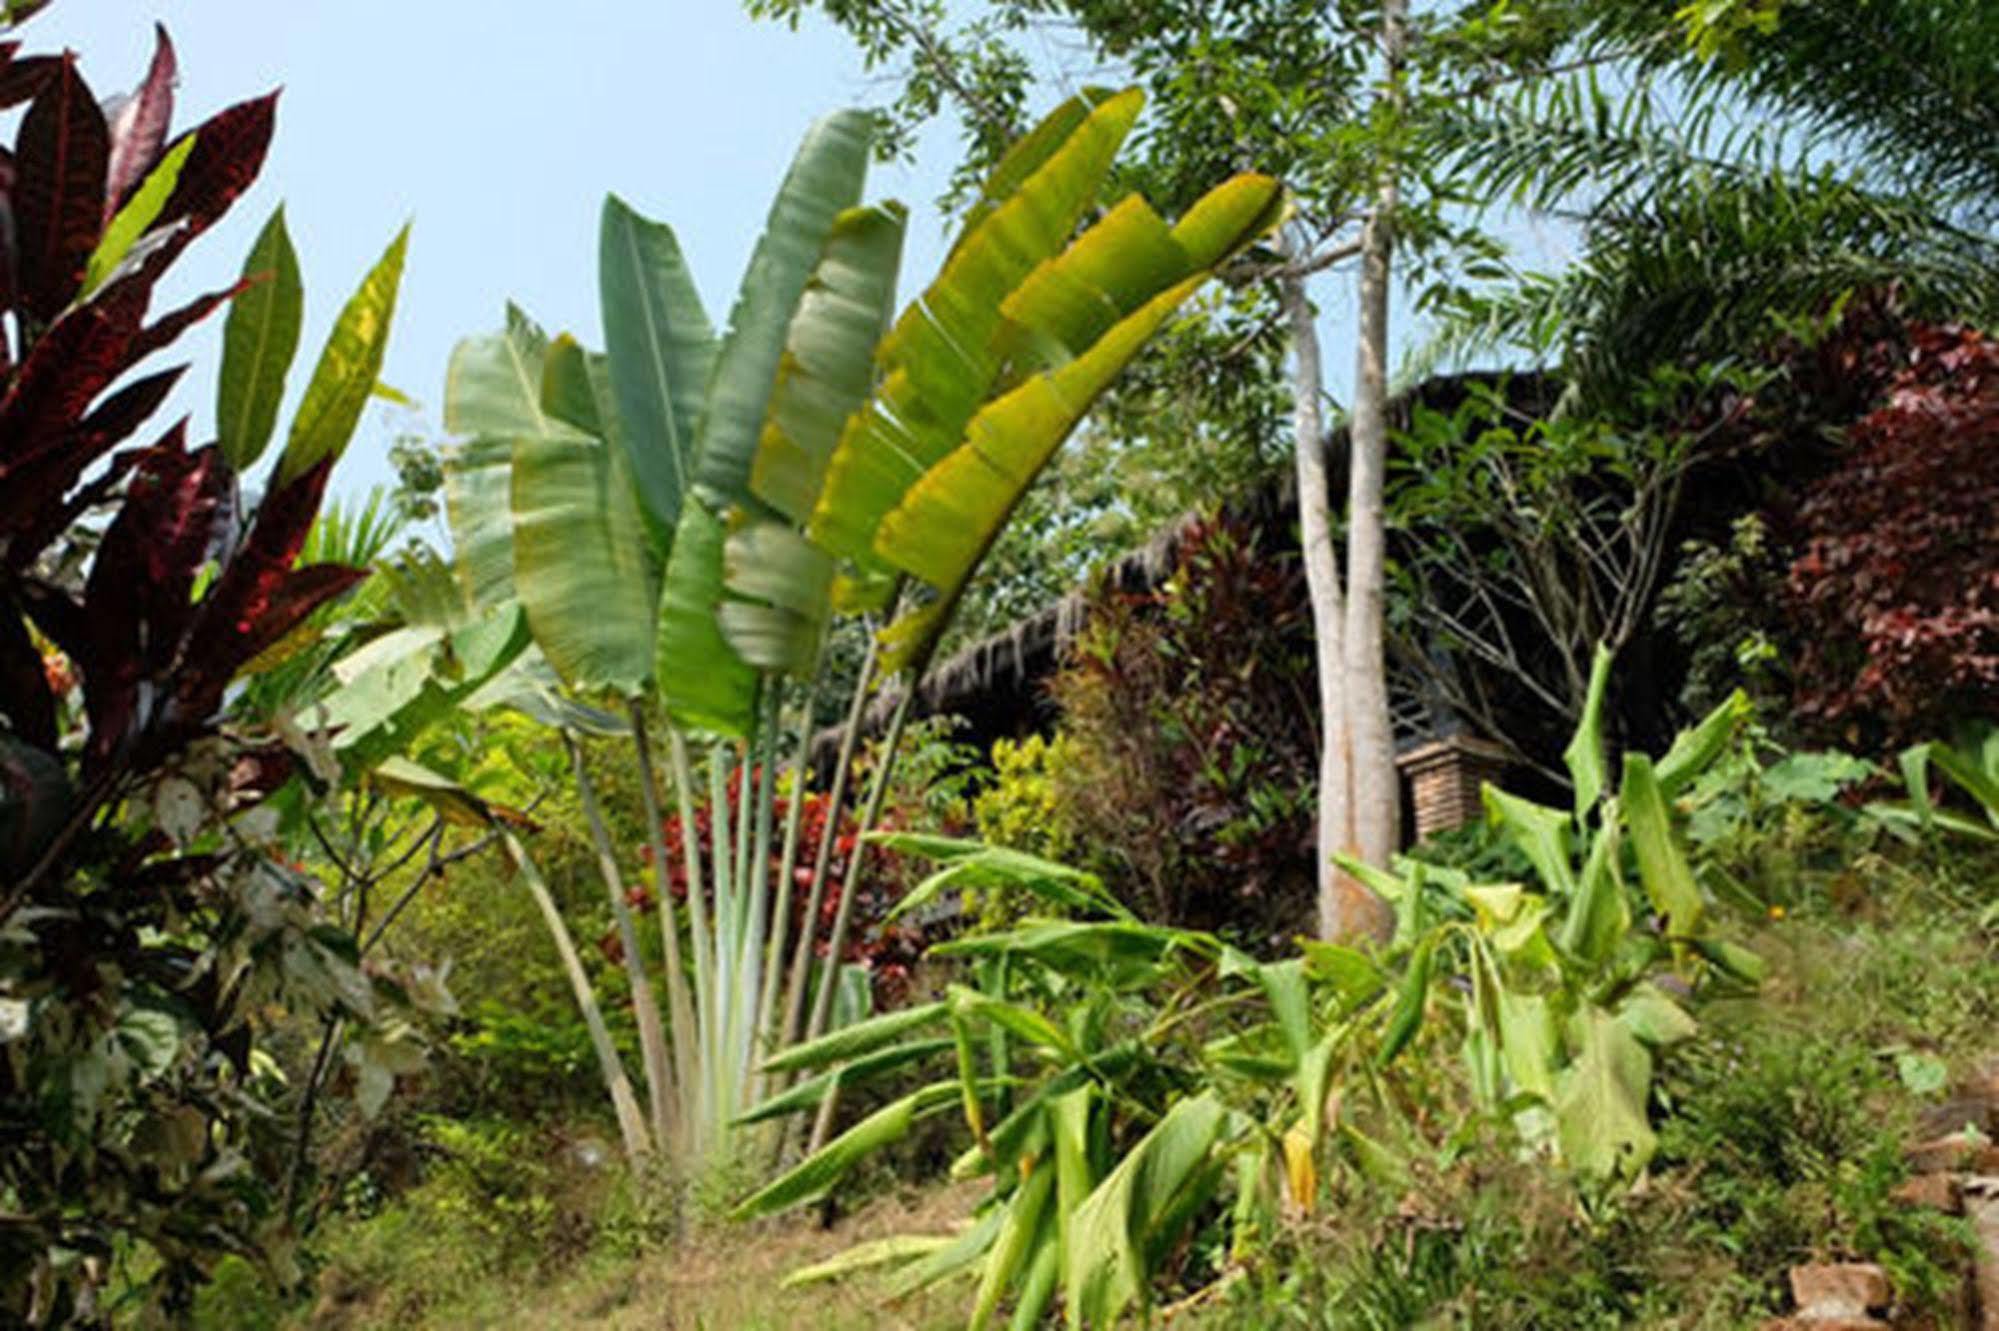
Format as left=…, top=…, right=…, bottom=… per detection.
left=1047, top=518, right=1317, bottom=951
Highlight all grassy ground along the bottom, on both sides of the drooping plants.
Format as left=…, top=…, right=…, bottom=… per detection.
left=204, top=823, right=1999, bottom=1331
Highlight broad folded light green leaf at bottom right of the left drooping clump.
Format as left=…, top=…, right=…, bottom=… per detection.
left=1063, top=1095, right=1227, bottom=1327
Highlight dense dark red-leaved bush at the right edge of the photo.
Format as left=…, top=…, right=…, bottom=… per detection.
left=1789, top=313, right=1999, bottom=751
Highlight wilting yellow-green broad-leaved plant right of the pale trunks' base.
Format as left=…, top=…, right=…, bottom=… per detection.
left=1347, top=650, right=1763, bottom=1183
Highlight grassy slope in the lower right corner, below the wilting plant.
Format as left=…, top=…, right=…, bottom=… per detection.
left=1191, top=831, right=1999, bottom=1331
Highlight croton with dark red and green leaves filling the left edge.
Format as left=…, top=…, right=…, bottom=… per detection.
left=0, top=15, right=404, bottom=1325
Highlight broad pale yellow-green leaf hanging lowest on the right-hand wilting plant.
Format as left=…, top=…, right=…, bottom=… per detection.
left=1555, top=1007, right=1657, bottom=1179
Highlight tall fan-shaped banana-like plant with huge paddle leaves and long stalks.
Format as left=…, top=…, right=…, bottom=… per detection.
left=415, top=92, right=1279, bottom=1169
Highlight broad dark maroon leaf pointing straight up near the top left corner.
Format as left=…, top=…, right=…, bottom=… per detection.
left=14, top=56, right=110, bottom=322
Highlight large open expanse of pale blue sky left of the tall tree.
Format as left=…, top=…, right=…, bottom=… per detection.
left=22, top=0, right=954, bottom=494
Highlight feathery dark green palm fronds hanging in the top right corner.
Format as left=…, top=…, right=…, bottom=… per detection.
left=1425, top=0, right=1999, bottom=394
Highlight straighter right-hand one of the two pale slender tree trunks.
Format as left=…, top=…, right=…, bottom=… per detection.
left=1343, top=0, right=1409, bottom=937
